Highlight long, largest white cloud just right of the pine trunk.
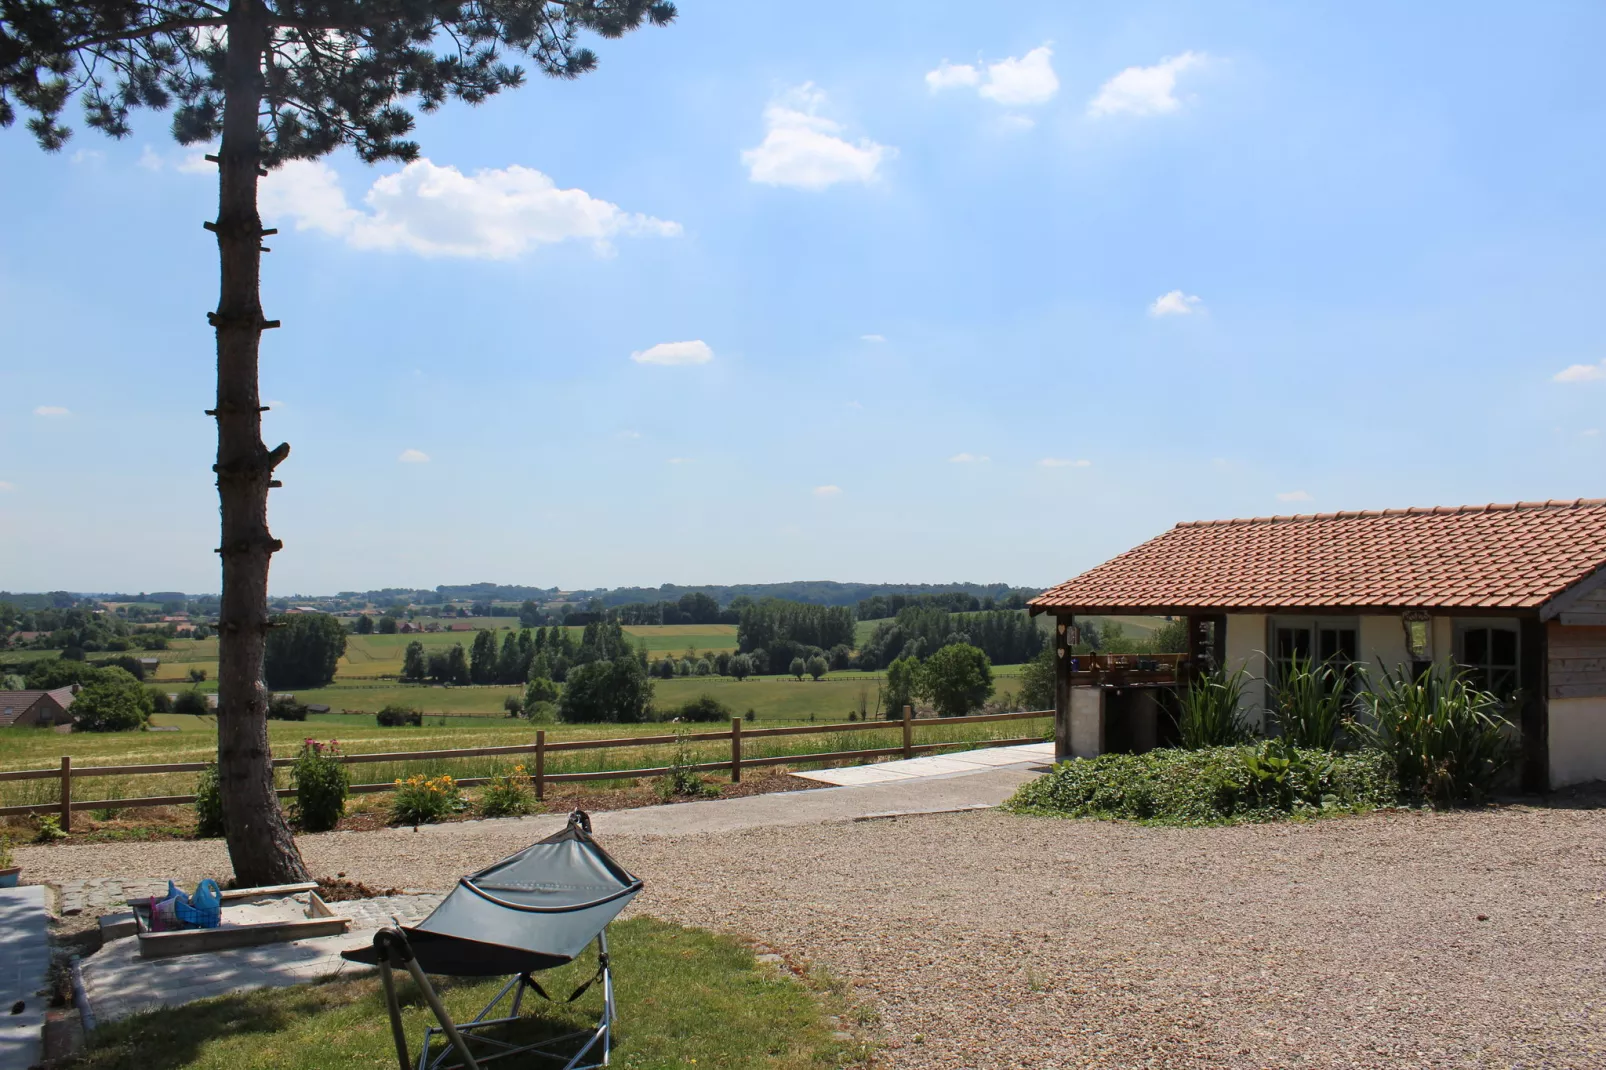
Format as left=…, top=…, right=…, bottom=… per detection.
left=262, top=159, right=681, bottom=260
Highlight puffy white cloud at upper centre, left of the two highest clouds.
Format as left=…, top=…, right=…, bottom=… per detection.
left=742, top=84, right=898, bottom=190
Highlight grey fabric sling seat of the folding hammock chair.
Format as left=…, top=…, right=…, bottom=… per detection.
left=342, top=815, right=642, bottom=977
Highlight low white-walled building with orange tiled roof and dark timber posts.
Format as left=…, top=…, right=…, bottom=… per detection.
left=1029, top=500, right=1606, bottom=789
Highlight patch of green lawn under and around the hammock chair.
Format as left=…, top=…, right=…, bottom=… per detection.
left=74, top=917, right=867, bottom=1070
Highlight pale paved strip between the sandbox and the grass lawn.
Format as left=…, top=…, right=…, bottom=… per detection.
left=77, top=895, right=442, bottom=1021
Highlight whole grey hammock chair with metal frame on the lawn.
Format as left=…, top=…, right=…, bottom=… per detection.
left=340, top=810, right=642, bottom=1070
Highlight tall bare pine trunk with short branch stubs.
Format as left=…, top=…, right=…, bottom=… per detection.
left=210, top=0, right=307, bottom=885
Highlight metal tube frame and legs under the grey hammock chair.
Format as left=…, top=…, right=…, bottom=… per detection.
left=374, top=929, right=615, bottom=1070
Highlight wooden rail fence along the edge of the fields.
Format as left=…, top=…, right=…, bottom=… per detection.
left=0, top=707, right=1054, bottom=832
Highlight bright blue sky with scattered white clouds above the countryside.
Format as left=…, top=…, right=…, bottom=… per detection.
left=0, top=0, right=1606, bottom=593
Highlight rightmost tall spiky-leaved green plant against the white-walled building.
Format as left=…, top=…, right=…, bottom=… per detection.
left=1359, top=665, right=1516, bottom=807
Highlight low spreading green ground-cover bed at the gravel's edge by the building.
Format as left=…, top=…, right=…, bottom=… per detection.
left=1005, top=741, right=1397, bottom=826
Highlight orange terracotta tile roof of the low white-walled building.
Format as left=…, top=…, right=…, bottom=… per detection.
left=1029, top=498, right=1606, bottom=612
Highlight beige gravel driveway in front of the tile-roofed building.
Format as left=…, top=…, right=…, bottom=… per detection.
left=15, top=808, right=1606, bottom=1068
